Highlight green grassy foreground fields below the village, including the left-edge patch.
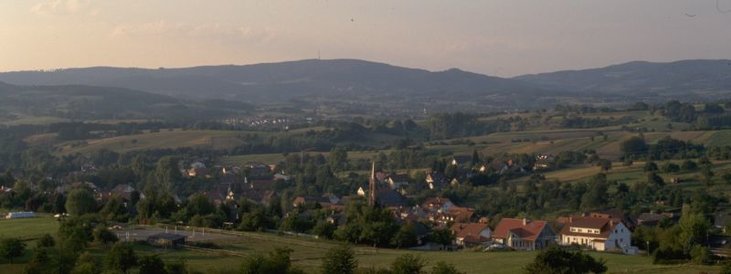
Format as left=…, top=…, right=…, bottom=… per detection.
left=0, top=218, right=717, bottom=273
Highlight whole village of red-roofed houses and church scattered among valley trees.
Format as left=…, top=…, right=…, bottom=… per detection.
left=3, top=155, right=678, bottom=255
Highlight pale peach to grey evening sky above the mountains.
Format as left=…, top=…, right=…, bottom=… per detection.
left=0, top=0, right=731, bottom=77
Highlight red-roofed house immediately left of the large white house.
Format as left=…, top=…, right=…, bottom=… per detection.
left=492, top=218, right=556, bottom=250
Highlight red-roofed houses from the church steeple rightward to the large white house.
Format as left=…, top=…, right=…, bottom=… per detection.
left=284, top=164, right=644, bottom=254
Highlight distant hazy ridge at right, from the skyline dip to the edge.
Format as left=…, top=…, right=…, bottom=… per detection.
left=513, top=60, right=731, bottom=100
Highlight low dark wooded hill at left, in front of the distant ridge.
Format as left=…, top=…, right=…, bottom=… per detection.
left=0, top=82, right=250, bottom=120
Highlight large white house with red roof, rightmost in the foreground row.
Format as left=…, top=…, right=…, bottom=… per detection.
left=560, top=215, right=632, bottom=251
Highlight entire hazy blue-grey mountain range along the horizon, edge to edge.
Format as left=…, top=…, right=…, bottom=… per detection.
left=0, top=59, right=731, bottom=109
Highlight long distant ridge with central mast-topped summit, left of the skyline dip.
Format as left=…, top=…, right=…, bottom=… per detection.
left=0, top=59, right=544, bottom=106
